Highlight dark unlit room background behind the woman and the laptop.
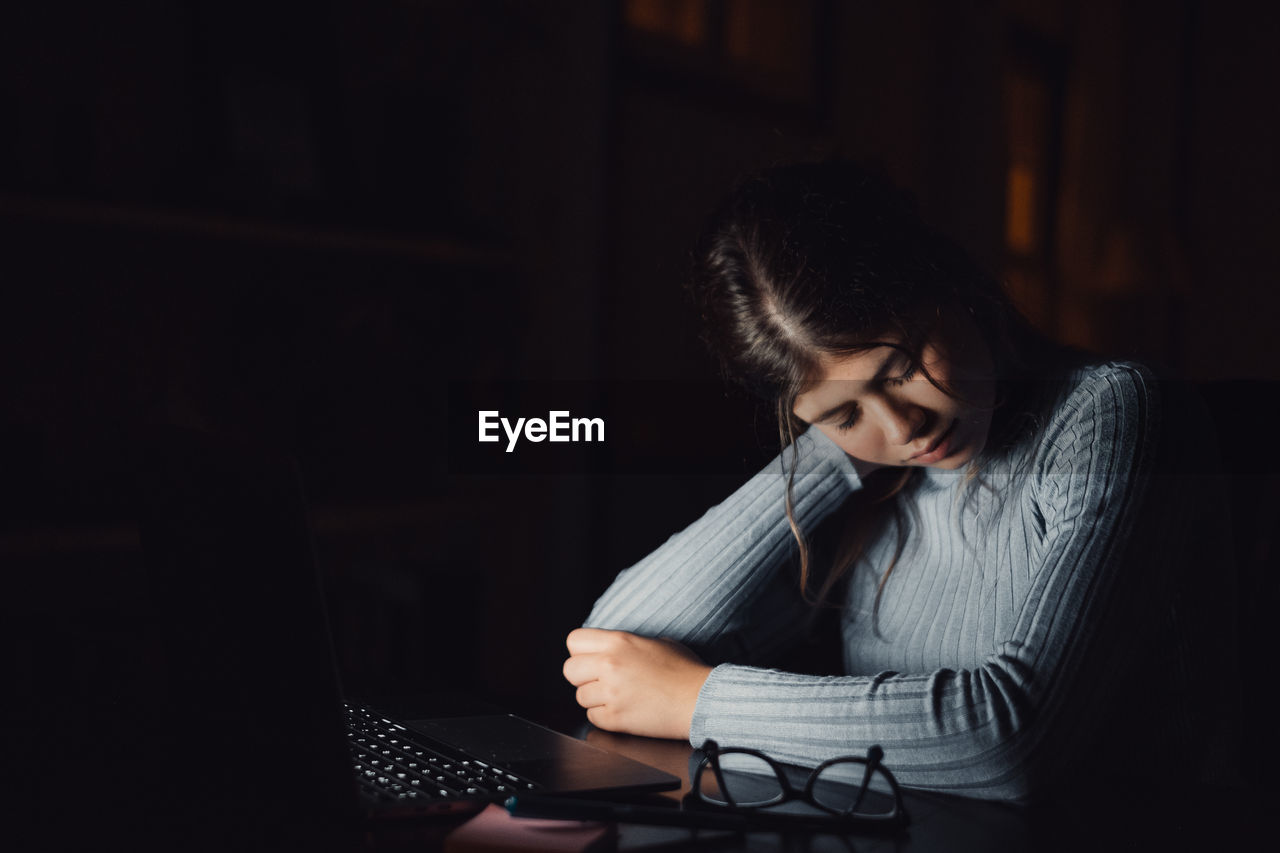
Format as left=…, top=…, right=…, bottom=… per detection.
left=0, top=0, right=1280, bottom=799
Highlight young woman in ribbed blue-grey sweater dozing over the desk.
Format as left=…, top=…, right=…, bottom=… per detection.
left=564, top=164, right=1234, bottom=799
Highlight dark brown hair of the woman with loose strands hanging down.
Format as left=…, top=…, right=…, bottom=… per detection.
left=690, top=163, right=1069, bottom=630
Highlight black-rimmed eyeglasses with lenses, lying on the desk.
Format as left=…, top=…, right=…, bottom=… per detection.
left=686, top=740, right=906, bottom=827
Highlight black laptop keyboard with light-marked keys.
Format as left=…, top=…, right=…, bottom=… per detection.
left=346, top=704, right=539, bottom=804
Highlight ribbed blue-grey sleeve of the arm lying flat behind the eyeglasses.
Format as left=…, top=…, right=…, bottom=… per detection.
left=690, top=369, right=1157, bottom=799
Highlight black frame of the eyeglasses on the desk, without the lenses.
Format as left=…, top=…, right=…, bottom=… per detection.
left=685, top=738, right=908, bottom=826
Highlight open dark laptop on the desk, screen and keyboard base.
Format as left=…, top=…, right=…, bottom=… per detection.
left=137, top=428, right=680, bottom=824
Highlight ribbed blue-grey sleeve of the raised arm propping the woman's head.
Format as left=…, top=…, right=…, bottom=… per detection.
left=585, top=428, right=861, bottom=660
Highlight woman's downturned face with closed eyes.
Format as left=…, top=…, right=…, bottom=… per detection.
left=794, top=318, right=996, bottom=469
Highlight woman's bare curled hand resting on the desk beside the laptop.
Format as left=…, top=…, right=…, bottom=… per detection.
left=564, top=628, right=712, bottom=740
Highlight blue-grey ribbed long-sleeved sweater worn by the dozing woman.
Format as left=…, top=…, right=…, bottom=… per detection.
left=586, top=362, right=1222, bottom=799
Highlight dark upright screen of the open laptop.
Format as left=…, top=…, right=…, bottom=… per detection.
left=138, top=429, right=356, bottom=816
